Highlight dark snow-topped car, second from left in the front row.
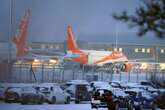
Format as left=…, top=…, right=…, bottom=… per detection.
left=21, top=87, right=44, bottom=104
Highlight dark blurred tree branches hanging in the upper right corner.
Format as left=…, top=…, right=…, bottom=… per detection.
left=112, top=0, right=165, bottom=38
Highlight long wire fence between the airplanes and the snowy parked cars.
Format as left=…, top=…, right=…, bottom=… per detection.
left=0, top=63, right=165, bottom=83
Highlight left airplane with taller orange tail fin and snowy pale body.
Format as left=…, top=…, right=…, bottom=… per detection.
left=12, top=9, right=78, bottom=61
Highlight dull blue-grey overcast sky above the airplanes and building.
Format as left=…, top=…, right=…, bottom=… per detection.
left=0, top=0, right=165, bottom=44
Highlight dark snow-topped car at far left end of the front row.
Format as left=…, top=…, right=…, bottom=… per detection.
left=4, top=87, right=21, bottom=103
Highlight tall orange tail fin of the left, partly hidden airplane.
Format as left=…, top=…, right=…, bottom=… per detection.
left=12, top=9, right=31, bottom=57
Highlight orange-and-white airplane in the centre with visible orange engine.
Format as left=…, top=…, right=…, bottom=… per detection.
left=67, top=25, right=132, bottom=72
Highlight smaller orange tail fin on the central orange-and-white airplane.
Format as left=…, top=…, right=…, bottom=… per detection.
left=67, top=25, right=80, bottom=53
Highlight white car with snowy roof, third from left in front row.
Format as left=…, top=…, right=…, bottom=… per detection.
left=35, top=83, right=70, bottom=104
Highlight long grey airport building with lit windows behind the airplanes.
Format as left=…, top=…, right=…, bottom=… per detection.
left=30, top=41, right=165, bottom=63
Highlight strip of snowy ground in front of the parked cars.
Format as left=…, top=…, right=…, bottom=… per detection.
left=0, top=104, right=107, bottom=110
